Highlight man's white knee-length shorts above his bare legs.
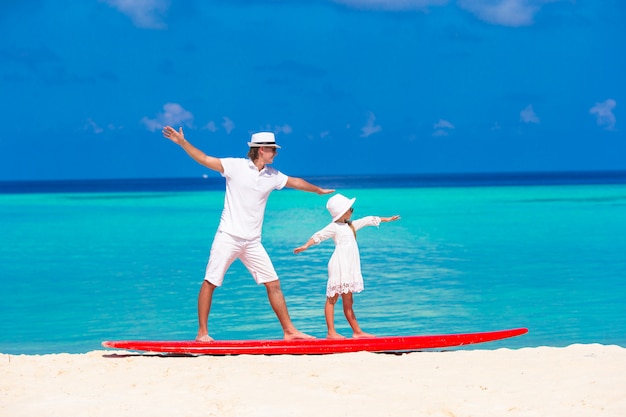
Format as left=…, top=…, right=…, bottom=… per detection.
left=204, top=231, right=278, bottom=287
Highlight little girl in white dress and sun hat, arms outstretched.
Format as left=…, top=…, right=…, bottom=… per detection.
left=293, top=194, right=400, bottom=339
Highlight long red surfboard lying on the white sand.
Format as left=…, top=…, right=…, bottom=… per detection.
left=102, top=328, right=528, bottom=355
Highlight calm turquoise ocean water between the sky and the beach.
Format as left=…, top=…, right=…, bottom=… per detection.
left=0, top=174, right=626, bottom=354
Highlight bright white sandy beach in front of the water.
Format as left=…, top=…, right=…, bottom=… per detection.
left=0, top=344, right=626, bottom=417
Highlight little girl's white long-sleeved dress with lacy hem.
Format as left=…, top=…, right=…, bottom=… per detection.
left=312, top=216, right=380, bottom=297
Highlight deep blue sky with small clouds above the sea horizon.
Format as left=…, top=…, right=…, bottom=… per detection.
left=0, top=0, right=626, bottom=181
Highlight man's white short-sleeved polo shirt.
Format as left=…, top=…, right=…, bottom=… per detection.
left=218, top=158, right=288, bottom=240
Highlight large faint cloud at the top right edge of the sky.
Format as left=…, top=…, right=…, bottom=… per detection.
left=458, top=0, right=555, bottom=27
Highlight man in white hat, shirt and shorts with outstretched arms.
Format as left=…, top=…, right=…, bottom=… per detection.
left=163, top=126, right=335, bottom=342
